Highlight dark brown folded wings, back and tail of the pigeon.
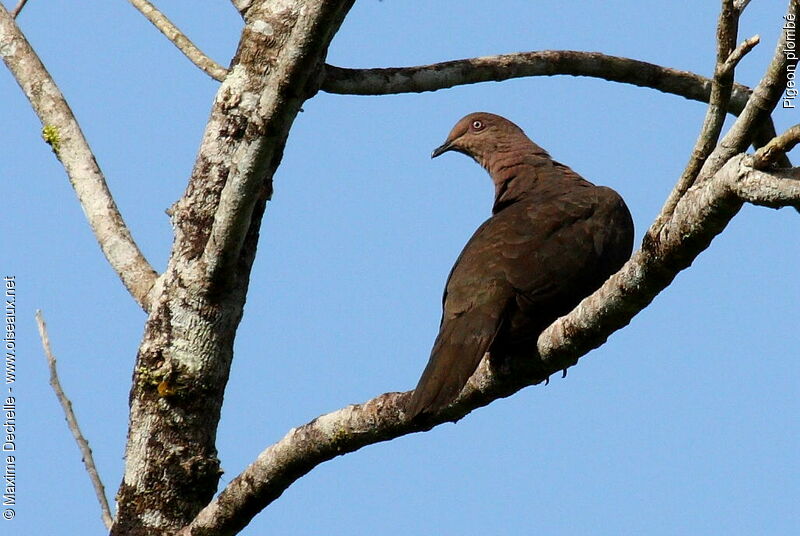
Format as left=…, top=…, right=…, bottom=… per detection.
left=410, top=178, right=632, bottom=416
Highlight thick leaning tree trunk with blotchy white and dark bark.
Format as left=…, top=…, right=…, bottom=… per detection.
left=111, top=0, right=352, bottom=536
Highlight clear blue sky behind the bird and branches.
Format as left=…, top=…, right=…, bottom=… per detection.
left=0, top=0, right=800, bottom=536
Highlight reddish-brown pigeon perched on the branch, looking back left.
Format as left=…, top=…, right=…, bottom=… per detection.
left=408, top=112, right=633, bottom=418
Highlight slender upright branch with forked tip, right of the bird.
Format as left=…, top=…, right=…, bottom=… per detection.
left=651, top=0, right=758, bottom=229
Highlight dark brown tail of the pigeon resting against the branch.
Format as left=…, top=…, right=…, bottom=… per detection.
left=408, top=311, right=499, bottom=419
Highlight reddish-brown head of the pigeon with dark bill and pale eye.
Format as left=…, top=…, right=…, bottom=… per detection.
left=431, top=112, right=530, bottom=169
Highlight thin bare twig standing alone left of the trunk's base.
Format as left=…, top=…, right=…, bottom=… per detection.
left=36, top=310, right=114, bottom=529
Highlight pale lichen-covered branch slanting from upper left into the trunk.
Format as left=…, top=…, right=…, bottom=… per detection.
left=0, top=4, right=156, bottom=310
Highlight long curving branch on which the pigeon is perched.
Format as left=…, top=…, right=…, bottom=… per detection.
left=178, top=155, right=800, bottom=536
